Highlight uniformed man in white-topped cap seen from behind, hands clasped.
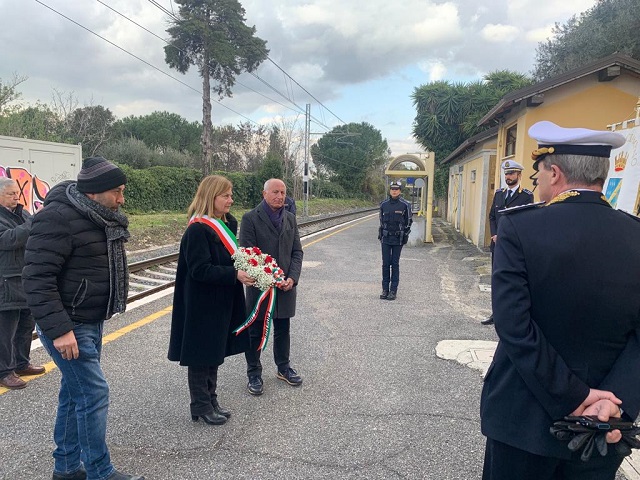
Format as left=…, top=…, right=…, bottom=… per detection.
left=480, top=122, right=640, bottom=480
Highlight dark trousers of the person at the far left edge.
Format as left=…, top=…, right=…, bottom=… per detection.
left=0, top=308, right=36, bottom=378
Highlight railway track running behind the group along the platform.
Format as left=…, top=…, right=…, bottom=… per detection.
left=127, top=208, right=378, bottom=303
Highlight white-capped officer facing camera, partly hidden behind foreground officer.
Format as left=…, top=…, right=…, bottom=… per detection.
left=480, top=160, right=533, bottom=325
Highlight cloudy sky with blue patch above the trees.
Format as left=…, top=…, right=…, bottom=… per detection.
left=0, top=0, right=596, bottom=155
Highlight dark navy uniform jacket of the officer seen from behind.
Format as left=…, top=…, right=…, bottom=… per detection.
left=480, top=191, right=640, bottom=459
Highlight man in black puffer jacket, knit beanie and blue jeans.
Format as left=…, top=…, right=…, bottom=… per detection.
left=22, top=157, right=144, bottom=480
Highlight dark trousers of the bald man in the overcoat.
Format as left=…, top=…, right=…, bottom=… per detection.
left=244, top=318, right=291, bottom=377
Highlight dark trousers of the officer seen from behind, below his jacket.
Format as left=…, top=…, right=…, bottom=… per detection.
left=482, top=438, right=623, bottom=480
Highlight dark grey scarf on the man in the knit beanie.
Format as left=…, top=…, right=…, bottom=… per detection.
left=67, top=183, right=129, bottom=318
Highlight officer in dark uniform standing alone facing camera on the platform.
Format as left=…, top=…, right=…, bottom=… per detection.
left=378, top=181, right=413, bottom=300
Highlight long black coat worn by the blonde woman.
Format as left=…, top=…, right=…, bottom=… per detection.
left=169, top=215, right=249, bottom=366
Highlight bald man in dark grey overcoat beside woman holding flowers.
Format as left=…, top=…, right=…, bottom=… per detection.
left=240, top=178, right=303, bottom=395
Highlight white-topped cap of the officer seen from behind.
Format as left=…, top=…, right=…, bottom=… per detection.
left=529, top=121, right=625, bottom=170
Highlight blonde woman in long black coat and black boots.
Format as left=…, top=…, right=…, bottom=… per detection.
left=169, top=175, right=254, bottom=425
